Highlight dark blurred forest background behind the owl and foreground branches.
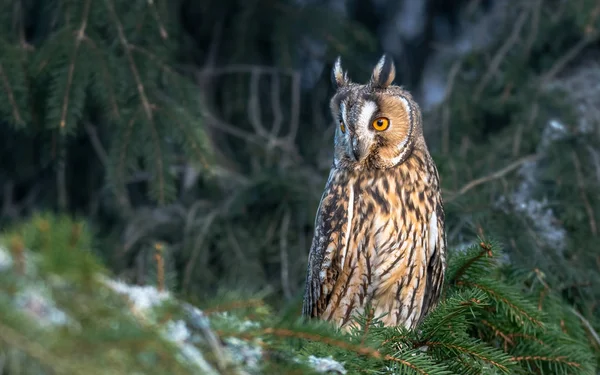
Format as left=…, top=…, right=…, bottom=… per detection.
left=0, top=0, right=600, bottom=356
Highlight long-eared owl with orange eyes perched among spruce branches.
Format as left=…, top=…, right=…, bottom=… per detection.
left=302, top=54, right=446, bottom=330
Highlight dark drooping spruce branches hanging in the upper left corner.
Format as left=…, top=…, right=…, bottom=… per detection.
left=0, top=0, right=210, bottom=214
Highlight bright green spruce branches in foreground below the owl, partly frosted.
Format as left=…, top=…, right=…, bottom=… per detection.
left=0, top=215, right=596, bottom=375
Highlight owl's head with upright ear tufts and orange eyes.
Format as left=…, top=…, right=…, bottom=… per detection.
left=330, top=55, right=423, bottom=169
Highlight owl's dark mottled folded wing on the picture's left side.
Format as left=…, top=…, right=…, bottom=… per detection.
left=302, top=168, right=353, bottom=317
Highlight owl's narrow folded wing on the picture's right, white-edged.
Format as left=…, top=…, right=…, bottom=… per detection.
left=420, top=198, right=446, bottom=320
